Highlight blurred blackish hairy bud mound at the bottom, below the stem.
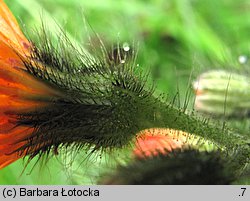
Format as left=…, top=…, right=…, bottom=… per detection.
left=100, top=149, right=236, bottom=185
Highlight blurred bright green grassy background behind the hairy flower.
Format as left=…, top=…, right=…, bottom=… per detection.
left=0, top=0, right=250, bottom=184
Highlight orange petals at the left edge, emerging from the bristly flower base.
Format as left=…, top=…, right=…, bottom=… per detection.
left=0, top=0, right=57, bottom=169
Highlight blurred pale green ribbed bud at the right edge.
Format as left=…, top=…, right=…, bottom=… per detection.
left=193, top=70, right=250, bottom=117
